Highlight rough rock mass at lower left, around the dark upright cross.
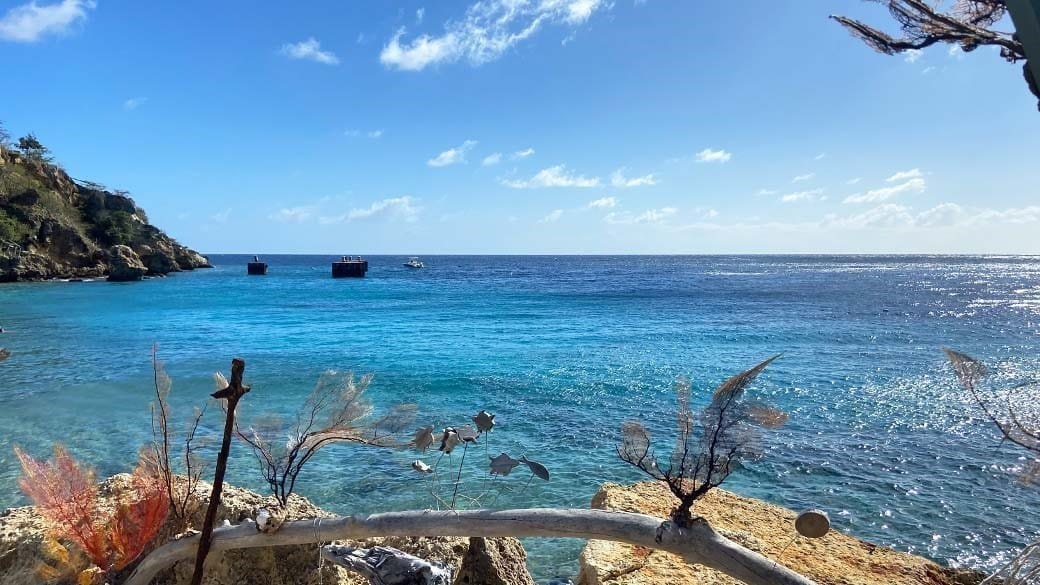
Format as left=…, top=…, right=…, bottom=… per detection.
left=0, top=475, right=534, bottom=585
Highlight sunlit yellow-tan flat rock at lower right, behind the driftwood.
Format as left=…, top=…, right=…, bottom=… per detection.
left=578, top=483, right=982, bottom=585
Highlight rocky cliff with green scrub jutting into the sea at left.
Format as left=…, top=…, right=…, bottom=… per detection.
left=0, top=147, right=210, bottom=282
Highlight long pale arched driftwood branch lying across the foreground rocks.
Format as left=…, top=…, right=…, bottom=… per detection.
left=125, top=508, right=812, bottom=585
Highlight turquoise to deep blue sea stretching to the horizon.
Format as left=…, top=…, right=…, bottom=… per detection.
left=0, top=256, right=1040, bottom=578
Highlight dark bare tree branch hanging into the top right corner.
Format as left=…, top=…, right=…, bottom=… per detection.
left=831, top=0, right=1040, bottom=107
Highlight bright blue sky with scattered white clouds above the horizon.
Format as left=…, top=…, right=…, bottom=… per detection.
left=0, top=0, right=1040, bottom=254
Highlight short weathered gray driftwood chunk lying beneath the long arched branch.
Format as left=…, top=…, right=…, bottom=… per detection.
left=321, top=544, right=452, bottom=585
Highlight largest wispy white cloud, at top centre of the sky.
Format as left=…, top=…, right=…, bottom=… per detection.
left=380, top=0, right=612, bottom=71
